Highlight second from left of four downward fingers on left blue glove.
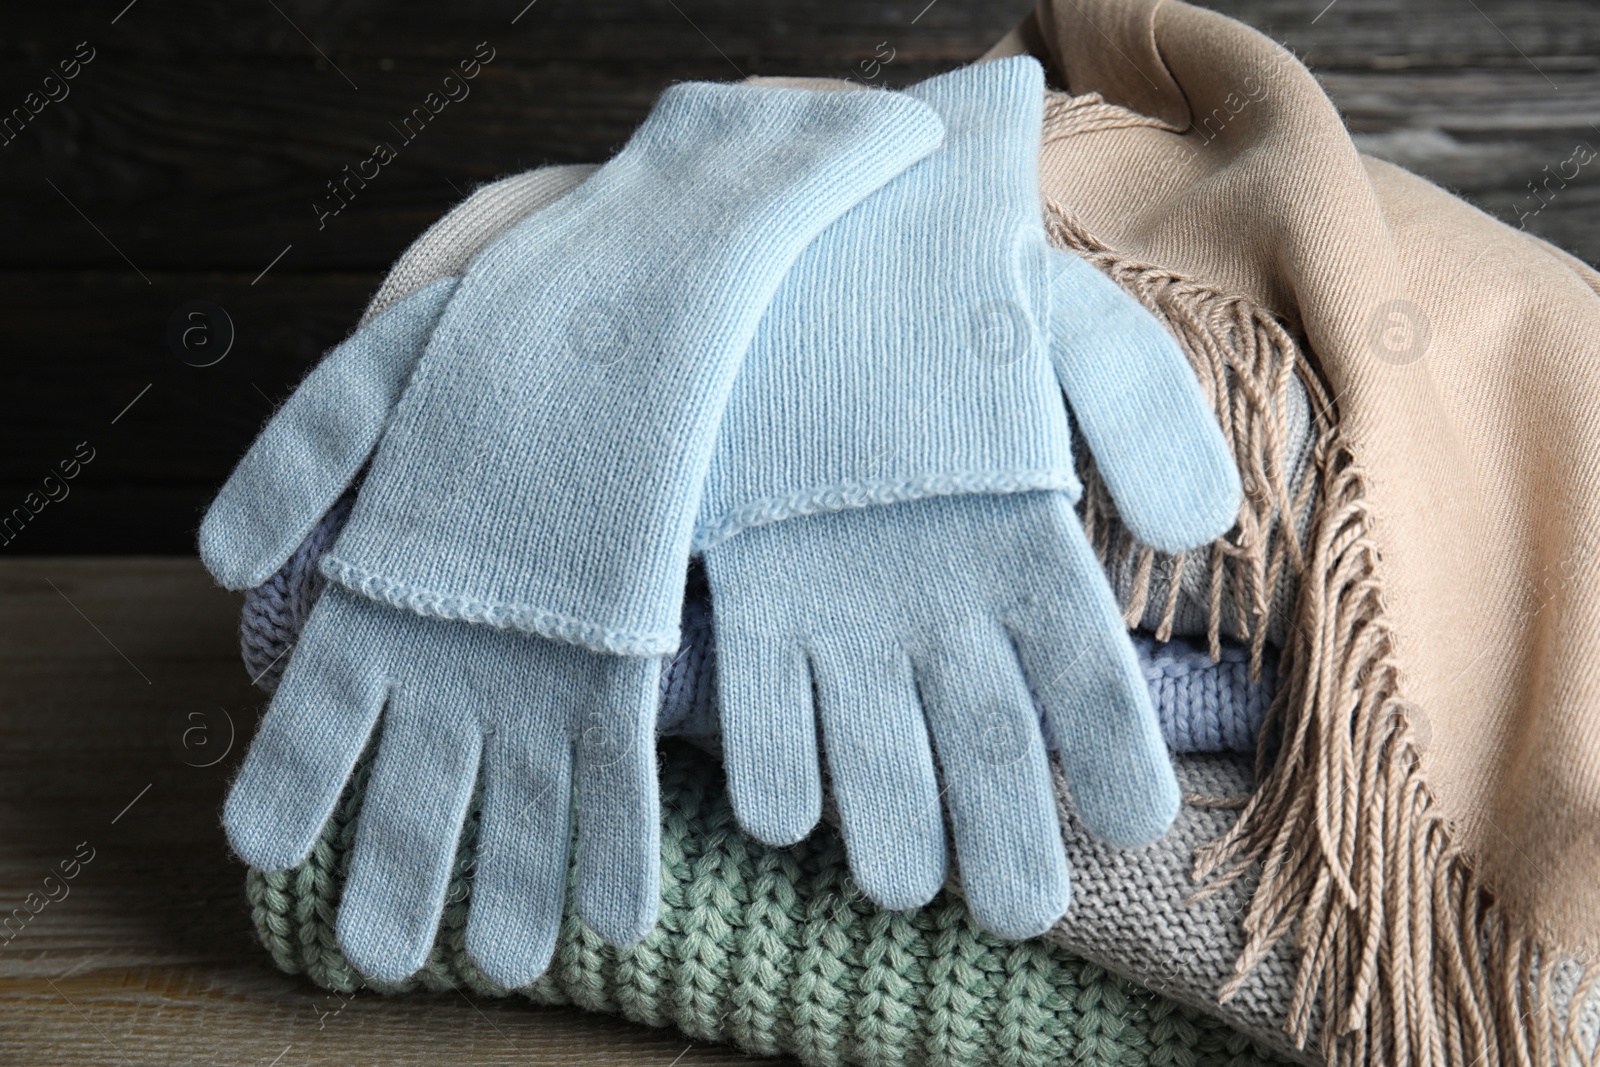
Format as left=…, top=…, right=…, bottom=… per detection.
left=338, top=668, right=482, bottom=982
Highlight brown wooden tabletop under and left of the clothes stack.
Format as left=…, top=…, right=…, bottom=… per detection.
left=0, top=558, right=782, bottom=1067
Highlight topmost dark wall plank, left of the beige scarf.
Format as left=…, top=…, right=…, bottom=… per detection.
left=0, top=0, right=1029, bottom=272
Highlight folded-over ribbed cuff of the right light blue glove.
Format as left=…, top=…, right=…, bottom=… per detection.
left=696, top=56, right=1081, bottom=552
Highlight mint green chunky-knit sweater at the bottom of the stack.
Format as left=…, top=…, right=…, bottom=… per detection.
left=246, top=742, right=1283, bottom=1067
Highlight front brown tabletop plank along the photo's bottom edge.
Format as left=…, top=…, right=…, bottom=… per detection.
left=0, top=966, right=771, bottom=1067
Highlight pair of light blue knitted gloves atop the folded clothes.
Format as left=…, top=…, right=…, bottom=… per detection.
left=200, top=58, right=1240, bottom=987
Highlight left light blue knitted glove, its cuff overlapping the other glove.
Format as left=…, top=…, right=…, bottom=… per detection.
left=200, top=83, right=942, bottom=985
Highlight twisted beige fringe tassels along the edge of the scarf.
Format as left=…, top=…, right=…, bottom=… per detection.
left=1048, top=203, right=1600, bottom=1067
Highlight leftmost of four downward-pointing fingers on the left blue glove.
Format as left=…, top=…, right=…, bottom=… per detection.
left=222, top=585, right=387, bottom=870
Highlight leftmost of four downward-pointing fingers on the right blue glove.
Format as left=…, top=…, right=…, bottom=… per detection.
left=712, top=620, right=822, bottom=846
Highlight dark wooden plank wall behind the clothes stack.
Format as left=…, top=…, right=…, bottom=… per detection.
left=0, top=0, right=1600, bottom=553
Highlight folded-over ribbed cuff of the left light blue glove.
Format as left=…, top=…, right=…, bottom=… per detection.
left=323, top=83, right=942, bottom=654
